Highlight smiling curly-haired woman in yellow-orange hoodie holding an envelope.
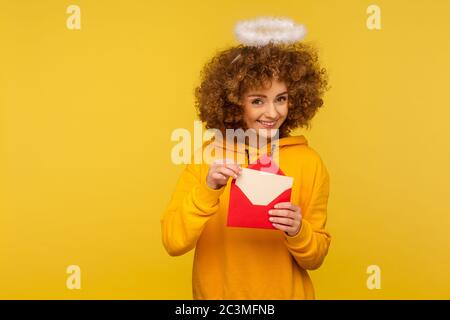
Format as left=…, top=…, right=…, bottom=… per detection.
left=161, top=19, right=331, bottom=299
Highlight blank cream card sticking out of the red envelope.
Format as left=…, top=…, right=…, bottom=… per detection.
left=235, top=168, right=294, bottom=206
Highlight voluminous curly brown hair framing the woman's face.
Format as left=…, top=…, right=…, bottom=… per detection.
left=195, top=42, right=329, bottom=137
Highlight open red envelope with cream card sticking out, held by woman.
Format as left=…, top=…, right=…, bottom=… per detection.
left=227, top=155, right=293, bottom=230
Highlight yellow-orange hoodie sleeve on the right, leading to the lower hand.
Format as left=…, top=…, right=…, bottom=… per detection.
left=285, top=161, right=331, bottom=270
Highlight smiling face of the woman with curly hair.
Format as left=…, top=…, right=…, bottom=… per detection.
left=243, top=79, right=288, bottom=137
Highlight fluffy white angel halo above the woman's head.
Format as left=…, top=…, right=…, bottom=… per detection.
left=234, top=17, right=306, bottom=46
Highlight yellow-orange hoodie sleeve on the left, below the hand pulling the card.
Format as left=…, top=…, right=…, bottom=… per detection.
left=160, top=164, right=225, bottom=256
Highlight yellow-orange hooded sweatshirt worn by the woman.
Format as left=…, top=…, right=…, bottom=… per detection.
left=161, top=135, right=331, bottom=300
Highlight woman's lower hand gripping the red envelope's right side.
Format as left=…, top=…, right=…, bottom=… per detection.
left=269, top=202, right=302, bottom=237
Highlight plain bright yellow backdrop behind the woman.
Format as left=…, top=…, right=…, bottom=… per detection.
left=0, top=0, right=450, bottom=299
